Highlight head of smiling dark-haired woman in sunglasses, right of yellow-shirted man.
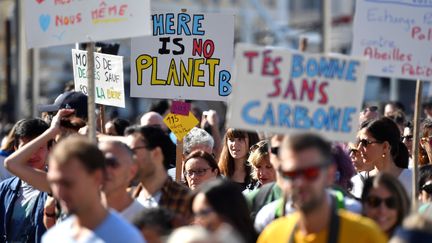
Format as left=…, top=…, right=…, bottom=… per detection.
left=361, top=173, right=410, bottom=238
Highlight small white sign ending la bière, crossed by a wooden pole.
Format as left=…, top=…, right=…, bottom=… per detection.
left=72, top=50, right=125, bottom=108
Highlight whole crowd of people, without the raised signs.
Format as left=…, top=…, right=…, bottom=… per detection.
left=0, top=91, right=432, bottom=243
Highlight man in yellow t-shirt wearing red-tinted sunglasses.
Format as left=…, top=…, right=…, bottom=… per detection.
left=258, top=134, right=386, bottom=243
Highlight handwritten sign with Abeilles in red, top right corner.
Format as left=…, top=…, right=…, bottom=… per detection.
left=352, top=0, right=432, bottom=80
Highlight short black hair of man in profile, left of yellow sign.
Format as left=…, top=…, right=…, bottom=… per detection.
left=125, top=126, right=176, bottom=170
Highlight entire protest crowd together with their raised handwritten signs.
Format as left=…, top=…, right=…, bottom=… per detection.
left=0, top=0, right=432, bottom=243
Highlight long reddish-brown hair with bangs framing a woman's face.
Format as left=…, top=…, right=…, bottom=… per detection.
left=218, top=128, right=259, bottom=178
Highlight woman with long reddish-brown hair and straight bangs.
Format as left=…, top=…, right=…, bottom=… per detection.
left=218, top=128, right=259, bottom=191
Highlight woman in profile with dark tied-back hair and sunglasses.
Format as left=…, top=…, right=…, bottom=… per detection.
left=352, top=117, right=412, bottom=197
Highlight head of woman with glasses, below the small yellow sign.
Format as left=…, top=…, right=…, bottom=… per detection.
left=183, top=150, right=220, bottom=190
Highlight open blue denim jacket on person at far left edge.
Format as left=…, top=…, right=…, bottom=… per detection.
left=0, top=176, right=47, bottom=243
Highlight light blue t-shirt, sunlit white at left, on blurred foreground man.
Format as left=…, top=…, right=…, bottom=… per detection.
left=42, top=211, right=145, bottom=243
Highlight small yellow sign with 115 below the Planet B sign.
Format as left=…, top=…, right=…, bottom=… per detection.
left=164, top=112, right=198, bottom=141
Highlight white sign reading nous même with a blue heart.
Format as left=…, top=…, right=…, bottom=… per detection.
left=23, top=0, right=151, bottom=48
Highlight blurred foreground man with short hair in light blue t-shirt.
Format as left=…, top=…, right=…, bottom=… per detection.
left=42, top=135, right=144, bottom=242
